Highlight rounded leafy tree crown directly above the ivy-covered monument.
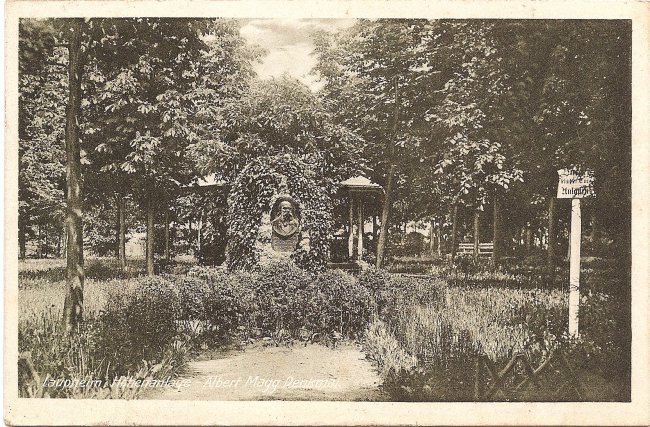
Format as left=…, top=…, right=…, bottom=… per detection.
left=190, top=76, right=362, bottom=187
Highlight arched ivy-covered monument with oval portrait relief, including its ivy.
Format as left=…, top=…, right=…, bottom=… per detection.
left=226, top=154, right=332, bottom=271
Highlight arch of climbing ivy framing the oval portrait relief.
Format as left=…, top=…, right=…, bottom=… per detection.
left=226, top=154, right=332, bottom=271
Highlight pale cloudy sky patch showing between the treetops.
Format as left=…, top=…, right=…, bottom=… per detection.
left=240, top=19, right=355, bottom=91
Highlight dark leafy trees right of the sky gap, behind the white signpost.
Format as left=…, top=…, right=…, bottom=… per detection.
left=316, top=20, right=631, bottom=268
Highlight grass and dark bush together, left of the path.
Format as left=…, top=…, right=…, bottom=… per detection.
left=18, top=270, right=188, bottom=399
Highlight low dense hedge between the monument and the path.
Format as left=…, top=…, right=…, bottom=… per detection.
left=182, top=262, right=371, bottom=339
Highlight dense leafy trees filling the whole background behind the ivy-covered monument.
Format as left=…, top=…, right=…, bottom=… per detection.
left=19, top=18, right=631, bottom=328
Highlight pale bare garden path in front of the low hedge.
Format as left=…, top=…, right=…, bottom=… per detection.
left=140, top=343, right=387, bottom=401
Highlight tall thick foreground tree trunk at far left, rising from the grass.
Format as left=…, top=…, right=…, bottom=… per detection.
left=63, top=18, right=84, bottom=332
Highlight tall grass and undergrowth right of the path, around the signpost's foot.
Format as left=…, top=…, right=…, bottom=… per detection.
left=364, top=266, right=630, bottom=401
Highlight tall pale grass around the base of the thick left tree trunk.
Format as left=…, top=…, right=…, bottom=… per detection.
left=18, top=258, right=186, bottom=398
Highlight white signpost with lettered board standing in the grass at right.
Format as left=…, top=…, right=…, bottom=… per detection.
left=557, top=169, right=594, bottom=337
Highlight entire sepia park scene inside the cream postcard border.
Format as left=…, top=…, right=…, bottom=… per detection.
left=19, top=18, right=632, bottom=402
